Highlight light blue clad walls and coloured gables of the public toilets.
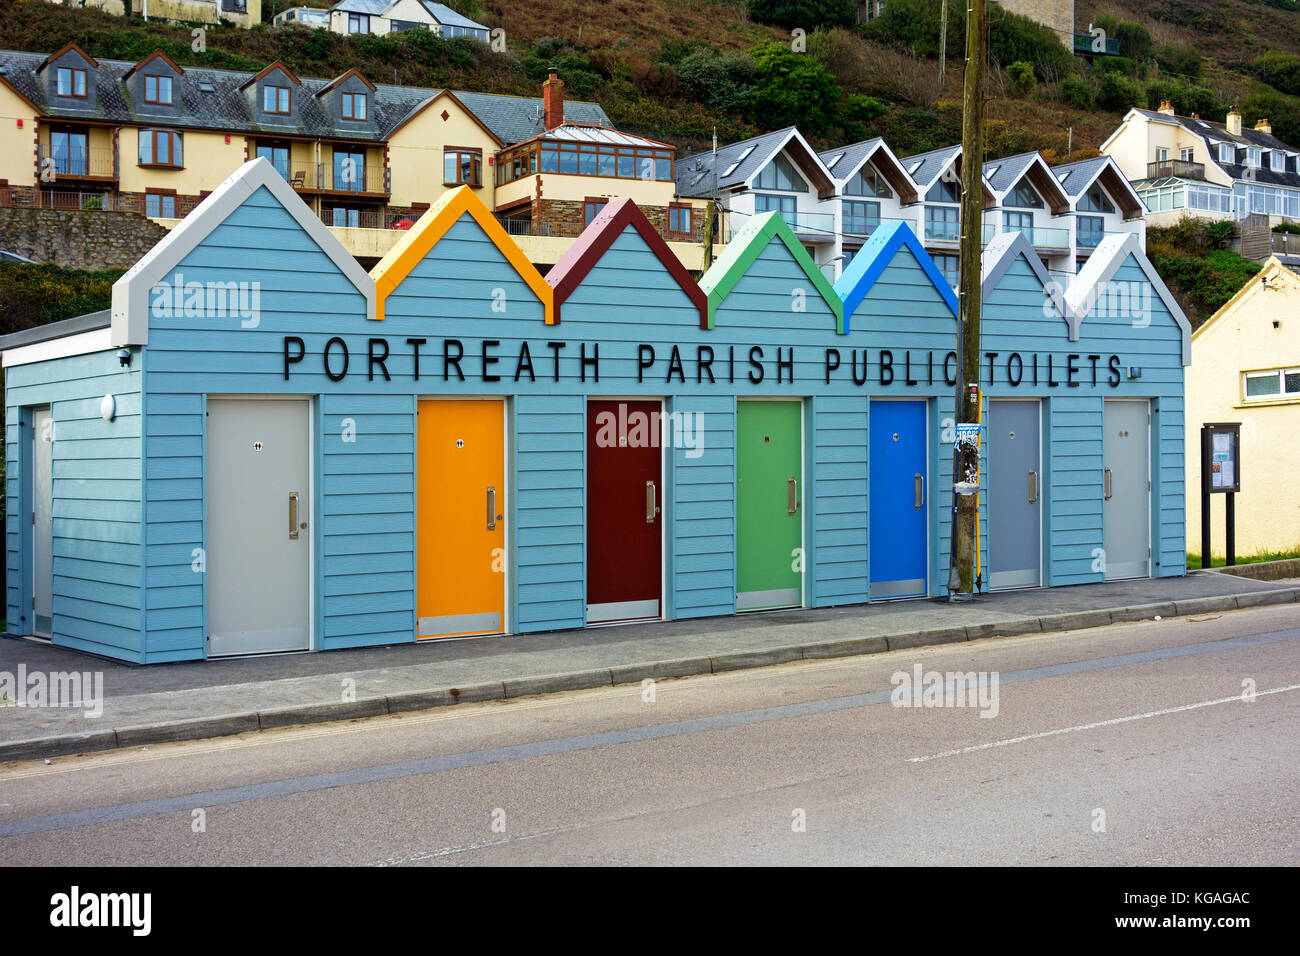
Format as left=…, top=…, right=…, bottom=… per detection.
left=4, top=160, right=1190, bottom=663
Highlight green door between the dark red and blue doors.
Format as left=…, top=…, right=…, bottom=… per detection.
left=736, top=402, right=803, bottom=611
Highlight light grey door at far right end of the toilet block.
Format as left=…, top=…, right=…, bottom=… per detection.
left=1102, top=401, right=1151, bottom=580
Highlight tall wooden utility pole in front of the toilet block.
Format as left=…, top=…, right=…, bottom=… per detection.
left=948, top=0, right=988, bottom=601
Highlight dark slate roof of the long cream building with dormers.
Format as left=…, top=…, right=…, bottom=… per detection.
left=0, top=47, right=612, bottom=144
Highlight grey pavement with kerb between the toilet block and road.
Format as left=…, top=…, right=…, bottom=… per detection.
left=0, top=571, right=1300, bottom=761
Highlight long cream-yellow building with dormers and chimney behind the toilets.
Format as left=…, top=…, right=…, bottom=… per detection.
left=0, top=44, right=702, bottom=269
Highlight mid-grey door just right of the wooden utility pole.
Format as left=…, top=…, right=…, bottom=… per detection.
left=988, top=402, right=1043, bottom=588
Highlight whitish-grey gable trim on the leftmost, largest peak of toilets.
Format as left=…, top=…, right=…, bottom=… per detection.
left=111, top=156, right=374, bottom=346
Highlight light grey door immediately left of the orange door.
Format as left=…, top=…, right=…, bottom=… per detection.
left=207, top=399, right=312, bottom=657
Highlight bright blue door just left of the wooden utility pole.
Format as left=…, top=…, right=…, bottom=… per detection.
left=867, top=402, right=930, bottom=598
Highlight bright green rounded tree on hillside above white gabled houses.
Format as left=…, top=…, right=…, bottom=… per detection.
left=748, top=43, right=842, bottom=135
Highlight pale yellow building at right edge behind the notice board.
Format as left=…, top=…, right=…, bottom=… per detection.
left=1187, top=256, right=1300, bottom=555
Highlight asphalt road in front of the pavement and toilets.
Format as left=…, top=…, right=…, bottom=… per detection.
left=0, top=605, right=1300, bottom=865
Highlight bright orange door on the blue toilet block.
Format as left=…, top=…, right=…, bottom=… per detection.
left=416, top=399, right=506, bottom=637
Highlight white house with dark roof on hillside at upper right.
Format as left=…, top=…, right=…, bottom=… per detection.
left=1101, top=100, right=1300, bottom=225
